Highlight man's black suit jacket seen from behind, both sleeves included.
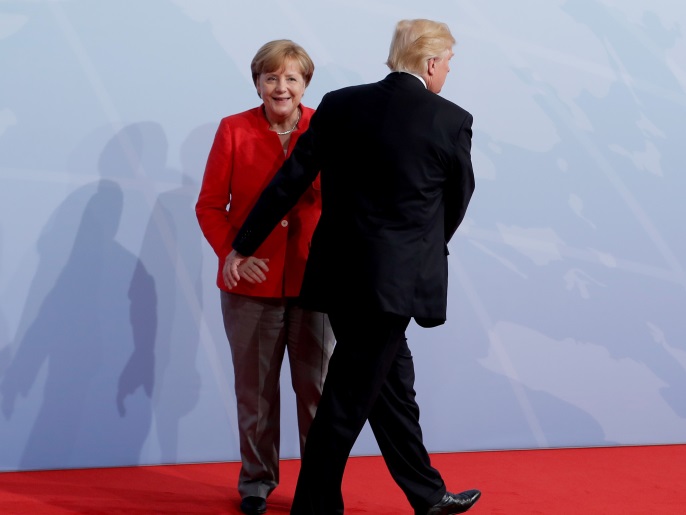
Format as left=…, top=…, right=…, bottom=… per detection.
left=233, top=72, right=474, bottom=327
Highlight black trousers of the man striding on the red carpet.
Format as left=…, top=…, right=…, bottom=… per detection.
left=291, top=308, right=446, bottom=515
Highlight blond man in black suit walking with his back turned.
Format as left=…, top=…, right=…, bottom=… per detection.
left=223, top=19, right=481, bottom=515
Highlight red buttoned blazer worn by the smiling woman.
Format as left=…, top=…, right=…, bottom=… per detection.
left=195, top=105, right=322, bottom=298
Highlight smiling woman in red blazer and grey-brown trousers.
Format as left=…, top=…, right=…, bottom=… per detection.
left=196, top=40, right=334, bottom=515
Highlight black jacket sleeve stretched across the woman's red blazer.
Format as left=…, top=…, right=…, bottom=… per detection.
left=232, top=116, right=320, bottom=257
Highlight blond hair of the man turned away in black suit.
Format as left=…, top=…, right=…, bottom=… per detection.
left=386, top=19, right=455, bottom=75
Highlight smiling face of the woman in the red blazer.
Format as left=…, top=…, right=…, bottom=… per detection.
left=255, top=59, right=305, bottom=121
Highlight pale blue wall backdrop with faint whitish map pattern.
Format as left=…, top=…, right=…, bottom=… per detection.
left=0, top=0, right=686, bottom=470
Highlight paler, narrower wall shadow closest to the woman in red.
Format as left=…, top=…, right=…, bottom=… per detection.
left=140, top=124, right=215, bottom=463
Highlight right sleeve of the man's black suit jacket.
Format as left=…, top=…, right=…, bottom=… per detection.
left=445, top=113, right=474, bottom=243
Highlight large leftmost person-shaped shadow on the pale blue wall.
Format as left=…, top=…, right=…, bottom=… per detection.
left=0, top=125, right=157, bottom=470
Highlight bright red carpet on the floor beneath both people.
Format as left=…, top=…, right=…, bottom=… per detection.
left=0, top=445, right=686, bottom=515
